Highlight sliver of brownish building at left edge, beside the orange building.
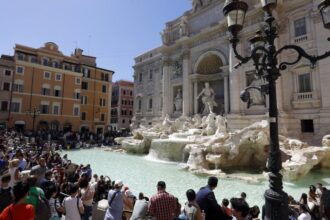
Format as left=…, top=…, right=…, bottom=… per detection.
left=0, top=55, right=15, bottom=128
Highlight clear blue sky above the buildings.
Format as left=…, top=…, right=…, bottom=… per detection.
left=0, top=0, right=192, bottom=81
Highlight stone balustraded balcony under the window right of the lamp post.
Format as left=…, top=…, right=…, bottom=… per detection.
left=292, top=91, right=321, bottom=109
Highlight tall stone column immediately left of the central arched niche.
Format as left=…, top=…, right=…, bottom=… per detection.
left=182, top=50, right=191, bottom=116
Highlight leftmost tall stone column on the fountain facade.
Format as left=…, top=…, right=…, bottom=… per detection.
left=162, top=57, right=171, bottom=117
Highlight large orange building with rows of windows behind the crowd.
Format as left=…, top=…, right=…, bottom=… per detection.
left=9, top=42, right=114, bottom=133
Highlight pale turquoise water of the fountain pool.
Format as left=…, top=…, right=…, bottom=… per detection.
left=63, top=149, right=330, bottom=207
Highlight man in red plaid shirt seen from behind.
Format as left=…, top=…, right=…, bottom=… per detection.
left=148, top=181, right=177, bottom=220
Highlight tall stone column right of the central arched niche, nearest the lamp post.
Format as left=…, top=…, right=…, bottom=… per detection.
left=229, top=44, right=241, bottom=114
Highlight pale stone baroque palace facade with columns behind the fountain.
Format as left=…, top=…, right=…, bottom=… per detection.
left=133, top=0, right=330, bottom=144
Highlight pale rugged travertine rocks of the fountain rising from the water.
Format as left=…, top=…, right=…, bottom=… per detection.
left=116, top=113, right=330, bottom=180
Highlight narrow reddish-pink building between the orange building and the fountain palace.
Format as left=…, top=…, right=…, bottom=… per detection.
left=110, top=80, right=134, bottom=130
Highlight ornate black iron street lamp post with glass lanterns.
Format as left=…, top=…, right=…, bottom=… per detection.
left=223, top=0, right=330, bottom=220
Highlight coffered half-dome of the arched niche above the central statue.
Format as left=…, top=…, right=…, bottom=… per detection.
left=194, top=50, right=227, bottom=74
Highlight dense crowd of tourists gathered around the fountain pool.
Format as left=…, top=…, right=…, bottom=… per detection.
left=0, top=130, right=330, bottom=220
